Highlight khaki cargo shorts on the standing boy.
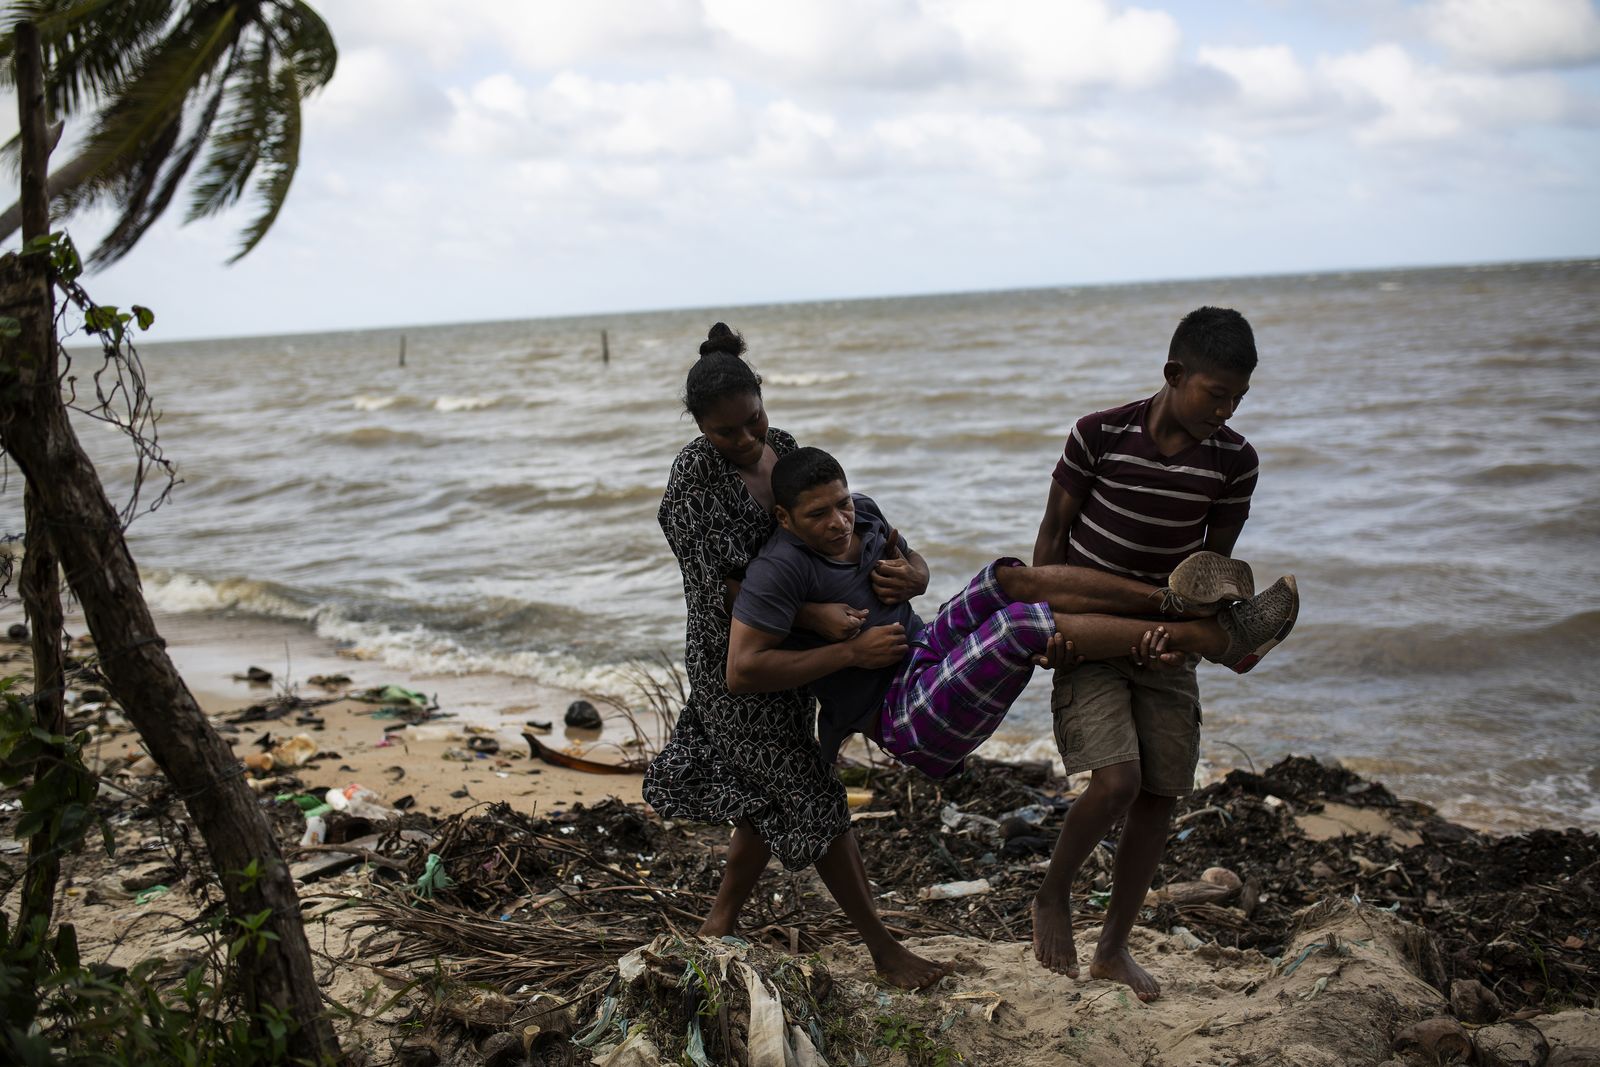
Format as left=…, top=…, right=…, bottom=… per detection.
left=1050, top=656, right=1200, bottom=797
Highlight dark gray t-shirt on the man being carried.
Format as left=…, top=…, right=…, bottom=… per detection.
left=733, top=493, right=922, bottom=763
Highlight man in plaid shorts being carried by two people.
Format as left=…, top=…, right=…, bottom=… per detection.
left=718, top=448, right=1298, bottom=979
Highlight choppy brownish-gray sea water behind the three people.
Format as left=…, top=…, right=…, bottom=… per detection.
left=15, top=261, right=1600, bottom=829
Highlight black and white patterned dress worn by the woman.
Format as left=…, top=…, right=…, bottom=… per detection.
left=645, top=429, right=850, bottom=869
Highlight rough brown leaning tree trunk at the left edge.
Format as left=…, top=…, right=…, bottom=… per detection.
left=0, top=27, right=339, bottom=1064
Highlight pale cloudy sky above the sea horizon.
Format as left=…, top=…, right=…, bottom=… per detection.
left=6, top=0, right=1600, bottom=339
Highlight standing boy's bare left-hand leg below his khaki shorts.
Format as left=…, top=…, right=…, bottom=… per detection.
left=1034, top=760, right=1154, bottom=977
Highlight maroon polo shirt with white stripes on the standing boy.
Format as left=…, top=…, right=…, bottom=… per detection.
left=1054, top=397, right=1259, bottom=584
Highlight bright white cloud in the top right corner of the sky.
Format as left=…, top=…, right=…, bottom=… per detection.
left=1422, top=0, right=1600, bottom=70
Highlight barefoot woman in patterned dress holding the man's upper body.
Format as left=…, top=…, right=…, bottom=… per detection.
left=645, top=323, right=947, bottom=987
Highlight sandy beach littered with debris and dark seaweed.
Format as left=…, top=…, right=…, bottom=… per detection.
left=0, top=613, right=1600, bottom=1067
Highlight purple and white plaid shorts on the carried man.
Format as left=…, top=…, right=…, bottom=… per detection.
left=878, top=557, right=1056, bottom=777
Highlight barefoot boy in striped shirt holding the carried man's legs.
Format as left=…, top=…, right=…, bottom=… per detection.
left=1034, top=307, right=1293, bottom=1000
